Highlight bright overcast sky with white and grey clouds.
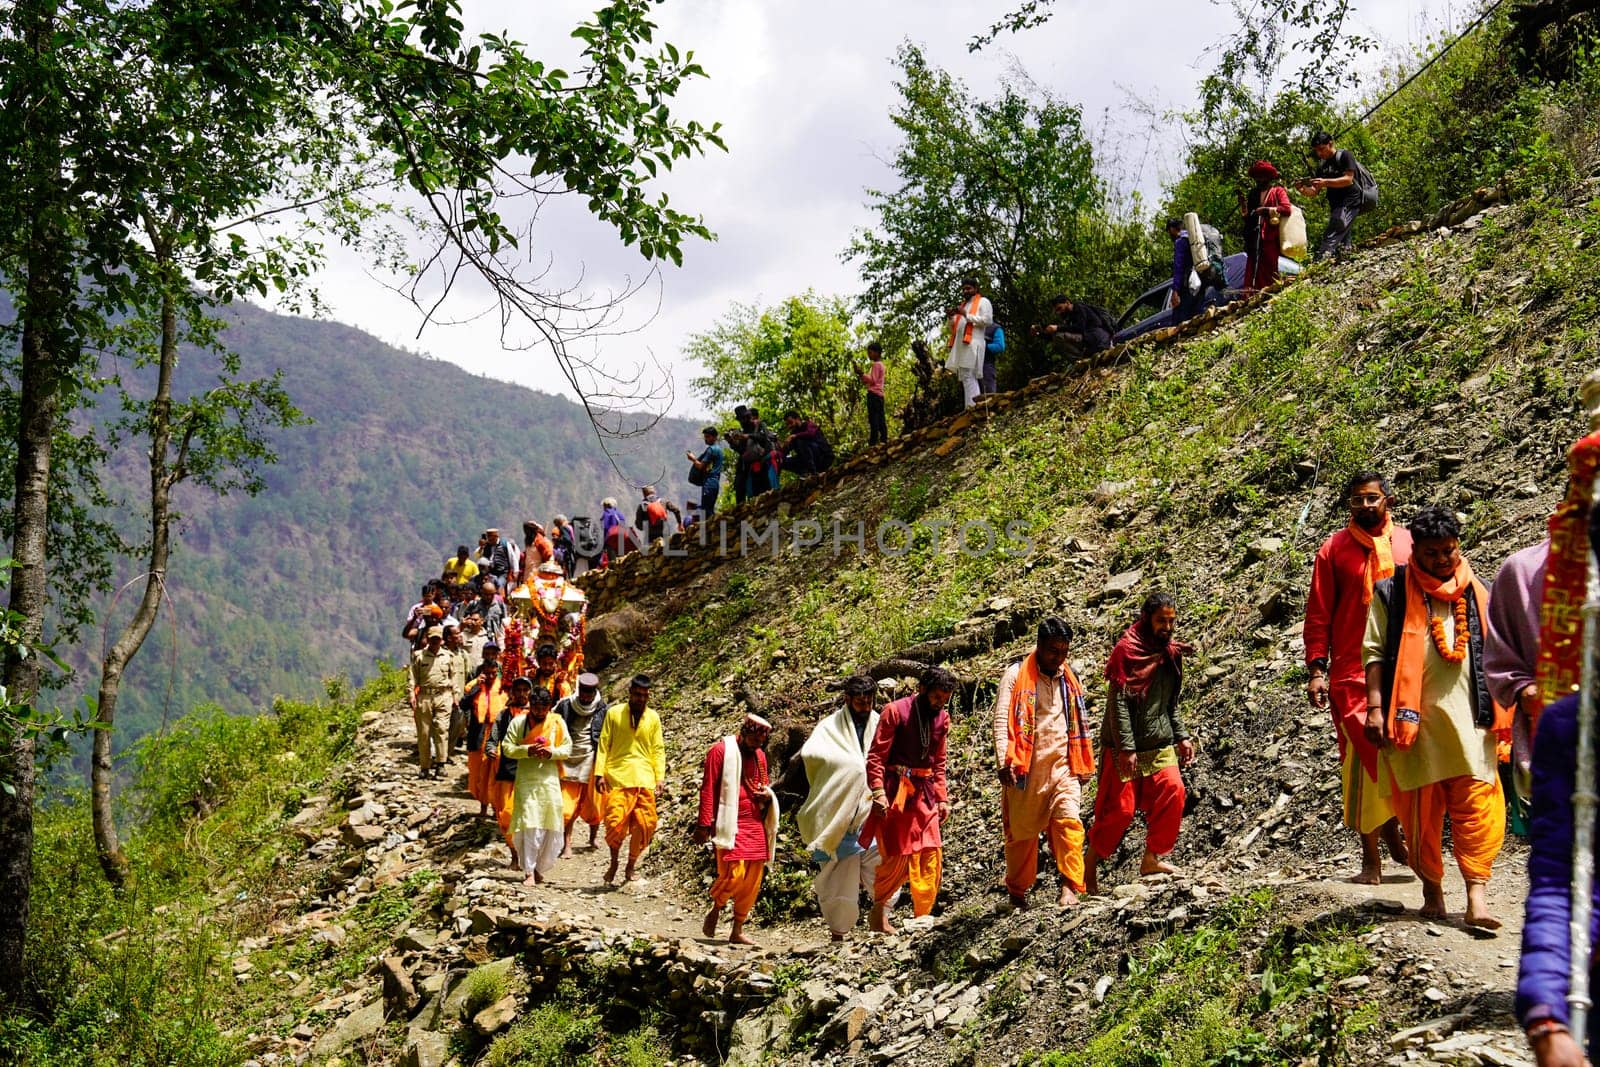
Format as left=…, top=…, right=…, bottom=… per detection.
left=297, top=0, right=1462, bottom=416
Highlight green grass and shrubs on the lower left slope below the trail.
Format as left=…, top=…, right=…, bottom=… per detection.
left=10, top=672, right=406, bottom=1067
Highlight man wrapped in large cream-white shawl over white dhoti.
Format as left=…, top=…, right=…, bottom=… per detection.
left=790, top=675, right=878, bottom=941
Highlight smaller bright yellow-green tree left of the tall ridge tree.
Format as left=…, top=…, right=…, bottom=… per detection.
left=683, top=290, right=872, bottom=448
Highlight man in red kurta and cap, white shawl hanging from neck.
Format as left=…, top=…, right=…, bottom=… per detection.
left=694, top=715, right=778, bottom=945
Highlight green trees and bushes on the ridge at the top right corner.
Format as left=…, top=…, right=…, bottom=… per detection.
left=1166, top=0, right=1600, bottom=254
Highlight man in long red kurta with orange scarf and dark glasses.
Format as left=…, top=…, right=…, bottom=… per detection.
left=1306, top=470, right=1411, bottom=886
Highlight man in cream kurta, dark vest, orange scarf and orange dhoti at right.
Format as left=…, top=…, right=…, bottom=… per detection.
left=1363, top=507, right=1510, bottom=929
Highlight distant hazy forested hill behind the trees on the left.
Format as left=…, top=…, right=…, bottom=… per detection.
left=50, top=306, right=699, bottom=747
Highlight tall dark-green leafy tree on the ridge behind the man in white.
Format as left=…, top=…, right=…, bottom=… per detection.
left=845, top=45, right=1158, bottom=384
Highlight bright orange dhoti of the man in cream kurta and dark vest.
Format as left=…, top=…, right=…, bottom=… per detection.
left=1389, top=771, right=1506, bottom=885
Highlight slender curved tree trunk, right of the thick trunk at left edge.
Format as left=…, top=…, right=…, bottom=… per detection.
left=90, top=275, right=182, bottom=889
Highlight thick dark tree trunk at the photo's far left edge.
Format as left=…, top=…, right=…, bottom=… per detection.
left=0, top=0, right=77, bottom=1006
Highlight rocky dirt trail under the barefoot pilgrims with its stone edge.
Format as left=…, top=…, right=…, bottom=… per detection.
left=265, top=694, right=1531, bottom=1067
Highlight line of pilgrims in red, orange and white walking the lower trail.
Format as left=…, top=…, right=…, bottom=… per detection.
left=411, top=412, right=1600, bottom=1064
